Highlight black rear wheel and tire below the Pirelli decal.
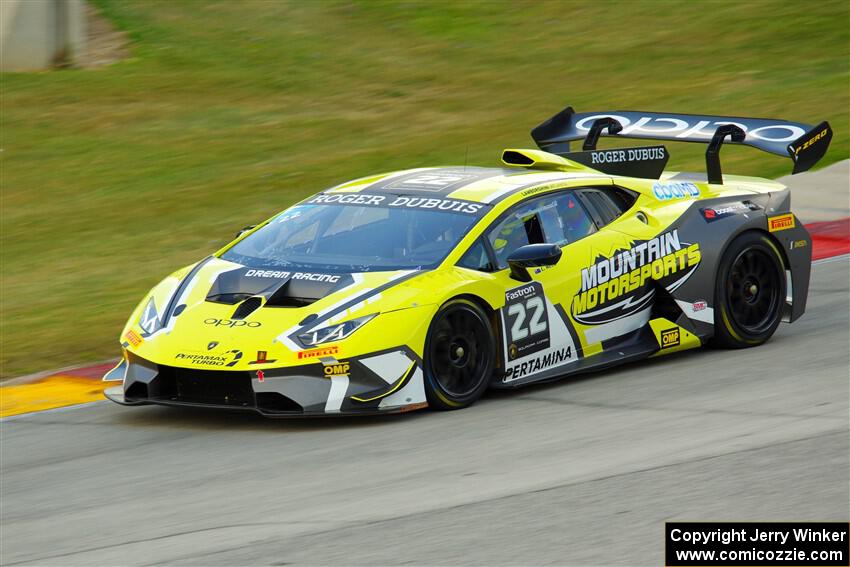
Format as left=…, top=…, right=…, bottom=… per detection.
left=713, top=232, right=786, bottom=348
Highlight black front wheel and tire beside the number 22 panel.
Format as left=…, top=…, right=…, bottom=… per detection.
left=424, top=299, right=496, bottom=410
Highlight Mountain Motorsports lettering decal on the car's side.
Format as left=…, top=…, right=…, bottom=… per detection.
left=572, top=229, right=702, bottom=325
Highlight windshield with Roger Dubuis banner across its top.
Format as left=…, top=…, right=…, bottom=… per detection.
left=221, top=194, right=485, bottom=272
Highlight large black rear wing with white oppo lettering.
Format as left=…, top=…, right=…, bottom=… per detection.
left=531, top=106, right=832, bottom=183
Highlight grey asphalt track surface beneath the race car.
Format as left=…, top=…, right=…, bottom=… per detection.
left=0, top=256, right=850, bottom=566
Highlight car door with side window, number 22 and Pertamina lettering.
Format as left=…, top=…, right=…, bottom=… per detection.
left=486, top=190, right=651, bottom=385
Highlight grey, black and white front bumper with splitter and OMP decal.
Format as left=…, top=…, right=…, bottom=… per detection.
left=104, top=348, right=427, bottom=418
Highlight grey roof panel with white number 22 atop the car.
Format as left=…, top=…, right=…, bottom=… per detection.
left=361, top=167, right=517, bottom=197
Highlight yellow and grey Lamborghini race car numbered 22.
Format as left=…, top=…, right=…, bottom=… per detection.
left=104, top=108, right=832, bottom=417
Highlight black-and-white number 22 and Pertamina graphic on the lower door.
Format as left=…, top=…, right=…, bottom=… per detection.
left=502, top=282, right=578, bottom=383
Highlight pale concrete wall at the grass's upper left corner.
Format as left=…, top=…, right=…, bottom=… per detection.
left=0, top=0, right=86, bottom=71
